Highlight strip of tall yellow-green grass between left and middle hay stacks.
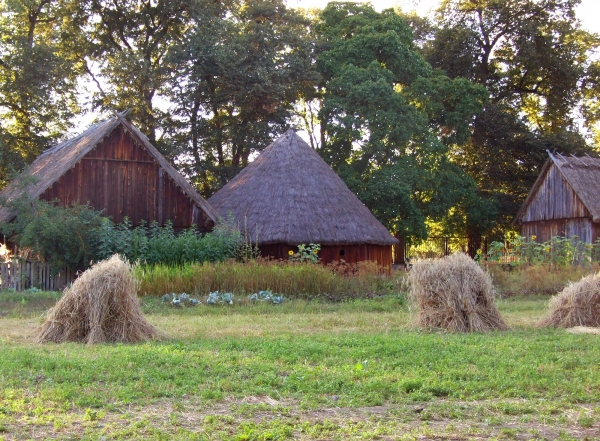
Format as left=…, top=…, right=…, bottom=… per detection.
left=136, top=259, right=403, bottom=300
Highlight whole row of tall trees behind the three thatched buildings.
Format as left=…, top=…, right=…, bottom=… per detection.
left=0, top=0, right=600, bottom=246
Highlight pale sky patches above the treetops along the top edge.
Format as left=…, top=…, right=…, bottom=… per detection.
left=286, top=0, right=600, bottom=33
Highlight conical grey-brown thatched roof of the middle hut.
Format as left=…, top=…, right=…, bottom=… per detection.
left=209, top=130, right=398, bottom=245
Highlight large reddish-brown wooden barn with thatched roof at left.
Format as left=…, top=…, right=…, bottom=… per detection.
left=0, top=114, right=218, bottom=231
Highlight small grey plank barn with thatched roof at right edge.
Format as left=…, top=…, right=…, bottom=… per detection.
left=513, top=152, right=600, bottom=243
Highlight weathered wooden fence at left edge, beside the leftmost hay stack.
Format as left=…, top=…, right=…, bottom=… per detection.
left=0, top=260, right=76, bottom=291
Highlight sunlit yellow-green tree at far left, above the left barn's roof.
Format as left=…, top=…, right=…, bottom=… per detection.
left=0, top=0, right=81, bottom=188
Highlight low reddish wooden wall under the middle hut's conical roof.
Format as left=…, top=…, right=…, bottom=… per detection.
left=259, top=244, right=392, bottom=269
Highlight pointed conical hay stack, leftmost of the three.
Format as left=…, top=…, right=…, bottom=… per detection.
left=37, top=255, right=159, bottom=344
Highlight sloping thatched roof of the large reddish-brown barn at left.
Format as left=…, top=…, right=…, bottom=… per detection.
left=0, top=114, right=218, bottom=222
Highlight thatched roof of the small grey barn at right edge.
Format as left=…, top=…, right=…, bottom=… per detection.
left=513, top=152, right=600, bottom=225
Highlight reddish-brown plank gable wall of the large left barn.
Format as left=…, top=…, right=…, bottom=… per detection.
left=40, top=126, right=211, bottom=230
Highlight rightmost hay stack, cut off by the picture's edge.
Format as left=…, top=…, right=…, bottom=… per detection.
left=541, top=273, right=600, bottom=328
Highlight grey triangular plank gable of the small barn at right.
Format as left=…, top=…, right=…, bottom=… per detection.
left=521, top=164, right=591, bottom=222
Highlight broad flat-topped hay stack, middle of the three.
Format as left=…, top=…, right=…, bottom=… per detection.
left=408, top=254, right=508, bottom=332
